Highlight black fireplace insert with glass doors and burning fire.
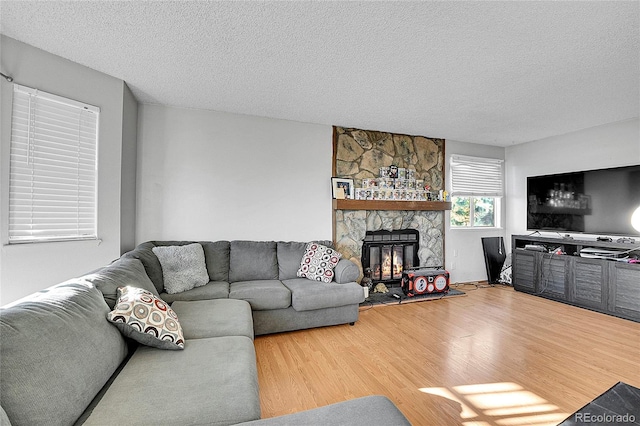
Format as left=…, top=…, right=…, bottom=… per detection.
left=362, top=229, right=420, bottom=283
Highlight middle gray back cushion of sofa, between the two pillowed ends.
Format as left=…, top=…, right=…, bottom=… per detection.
left=229, top=241, right=278, bottom=283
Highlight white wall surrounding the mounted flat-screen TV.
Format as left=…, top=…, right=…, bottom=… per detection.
left=506, top=119, right=640, bottom=245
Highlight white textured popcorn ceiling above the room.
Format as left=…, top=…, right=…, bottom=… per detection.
left=0, top=0, right=640, bottom=145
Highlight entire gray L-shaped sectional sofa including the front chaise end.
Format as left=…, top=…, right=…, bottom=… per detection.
left=0, top=241, right=409, bottom=426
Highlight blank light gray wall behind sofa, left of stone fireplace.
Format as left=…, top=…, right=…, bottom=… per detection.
left=136, top=105, right=333, bottom=243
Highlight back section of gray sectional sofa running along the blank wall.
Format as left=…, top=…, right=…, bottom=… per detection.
left=123, top=241, right=364, bottom=336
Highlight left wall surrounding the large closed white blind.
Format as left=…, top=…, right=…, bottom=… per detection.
left=0, top=36, right=132, bottom=305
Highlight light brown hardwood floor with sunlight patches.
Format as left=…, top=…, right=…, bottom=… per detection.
left=255, top=286, right=640, bottom=425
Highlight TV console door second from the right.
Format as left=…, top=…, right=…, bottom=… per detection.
left=571, top=257, right=608, bottom=310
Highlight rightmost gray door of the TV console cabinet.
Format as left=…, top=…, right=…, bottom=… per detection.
left=609, top=262, right=640, bottom=320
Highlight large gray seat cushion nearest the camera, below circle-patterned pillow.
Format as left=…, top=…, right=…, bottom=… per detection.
left=85, top=336, right=260, bottom=426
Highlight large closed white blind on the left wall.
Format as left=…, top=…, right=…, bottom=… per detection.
left=9, top=84, right=100, bottom=243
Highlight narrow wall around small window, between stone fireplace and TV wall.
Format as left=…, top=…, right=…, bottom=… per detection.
left=445, top=140, right=506, bottom=283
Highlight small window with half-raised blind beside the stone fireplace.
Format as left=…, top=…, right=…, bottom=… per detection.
left=450, top=155, right=503, bottom=228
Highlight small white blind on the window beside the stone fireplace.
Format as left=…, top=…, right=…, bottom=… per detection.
left=450, top=155, right=503, bottom=197
